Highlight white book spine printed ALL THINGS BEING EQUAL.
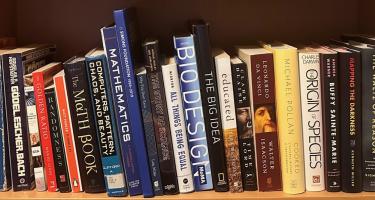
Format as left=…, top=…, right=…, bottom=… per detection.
left=162, top=63, right=194, bottom=193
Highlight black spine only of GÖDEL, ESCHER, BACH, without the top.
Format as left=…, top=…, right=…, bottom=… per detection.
left=3, top=54, right=35, bottom=191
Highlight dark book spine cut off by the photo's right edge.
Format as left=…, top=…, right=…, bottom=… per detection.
left=361, top=50, right=375, bottom=191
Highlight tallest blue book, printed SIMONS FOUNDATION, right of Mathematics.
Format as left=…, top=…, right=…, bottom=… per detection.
left=113, top=8, right=154, bottom=197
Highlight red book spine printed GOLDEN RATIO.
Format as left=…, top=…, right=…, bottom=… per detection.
left=33, top=72, right=57, bottom=192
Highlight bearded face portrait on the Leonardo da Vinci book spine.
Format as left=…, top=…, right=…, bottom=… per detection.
left=254, top=104, right=277, bottom=134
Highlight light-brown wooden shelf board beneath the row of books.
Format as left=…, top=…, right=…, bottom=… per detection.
left=0, top=191, right=375, bottom=200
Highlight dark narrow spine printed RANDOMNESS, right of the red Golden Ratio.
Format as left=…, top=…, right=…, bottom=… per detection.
left=44, top=87, right=71, bottom=192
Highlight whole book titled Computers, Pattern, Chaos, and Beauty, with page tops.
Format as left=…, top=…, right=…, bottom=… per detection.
left=85, top=47, right=127, bottom=196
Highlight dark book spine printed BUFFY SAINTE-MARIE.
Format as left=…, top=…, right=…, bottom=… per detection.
left=320, top=54, right=341, bottom=192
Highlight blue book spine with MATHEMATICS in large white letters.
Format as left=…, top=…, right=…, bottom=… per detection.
left=102, top=27, right=142, bottom=195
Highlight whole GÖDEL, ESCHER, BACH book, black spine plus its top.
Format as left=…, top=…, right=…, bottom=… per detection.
left=3, top=45, right=56, bottom=191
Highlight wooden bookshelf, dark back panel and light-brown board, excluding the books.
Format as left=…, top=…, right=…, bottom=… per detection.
left=0, top=0, right=375, bottom=200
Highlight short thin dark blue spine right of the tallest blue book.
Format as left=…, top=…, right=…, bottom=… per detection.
left=137, top=74, right=163, bottom=195
